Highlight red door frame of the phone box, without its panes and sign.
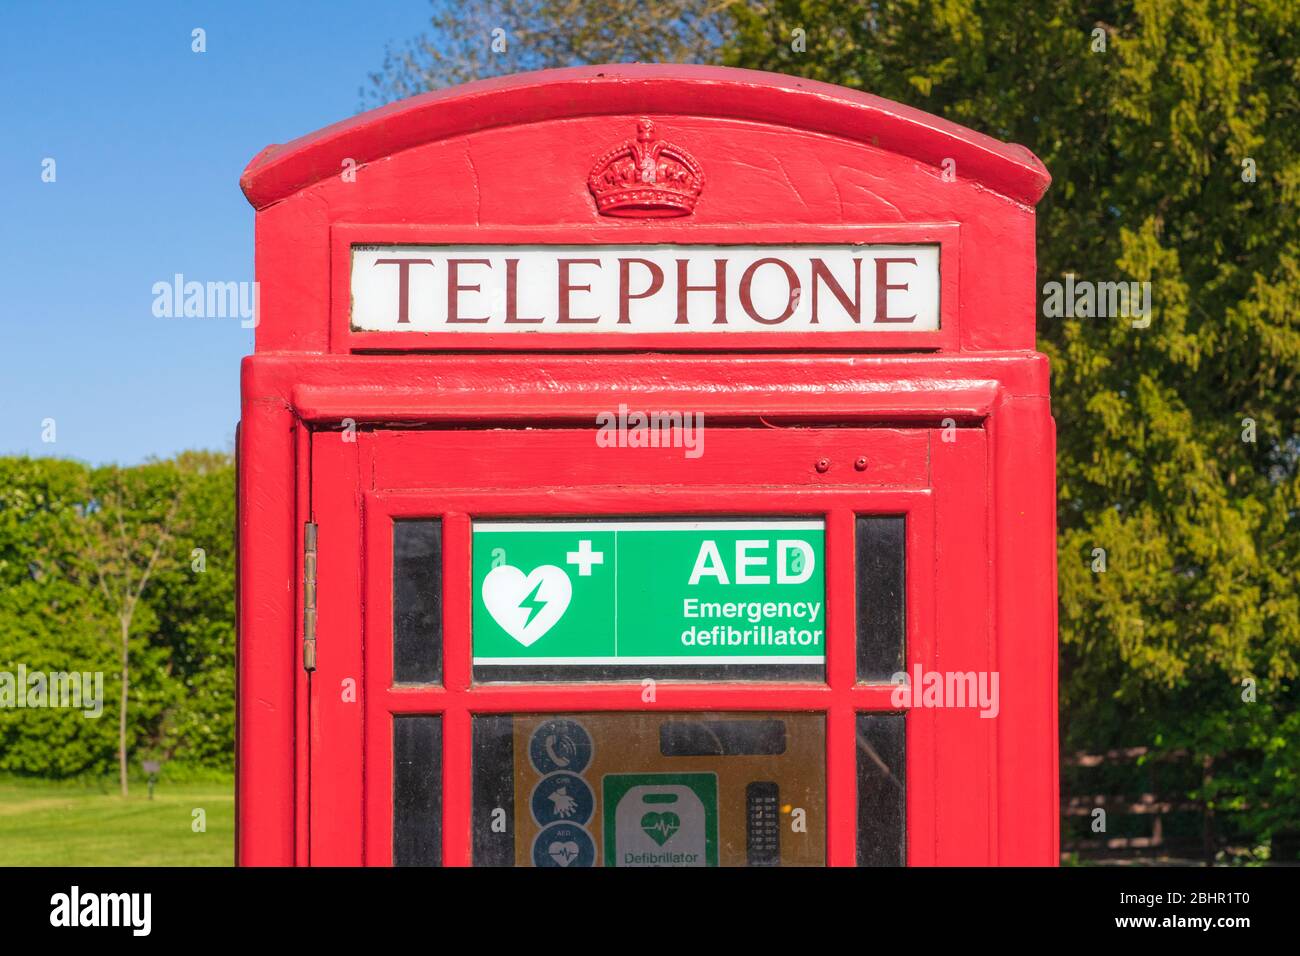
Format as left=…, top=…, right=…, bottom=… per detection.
left=309, top=427, right=997, bottom=865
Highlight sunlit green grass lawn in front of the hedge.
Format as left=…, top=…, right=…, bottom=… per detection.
left=0, top=778, right=235, bottom=866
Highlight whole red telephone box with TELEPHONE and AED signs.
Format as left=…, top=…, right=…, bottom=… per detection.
left=238, top=66, right=1058, bottom=866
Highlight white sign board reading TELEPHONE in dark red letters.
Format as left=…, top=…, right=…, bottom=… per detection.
left=351, top=245, right=939, bottom=334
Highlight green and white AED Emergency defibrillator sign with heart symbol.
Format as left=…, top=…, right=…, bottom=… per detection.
left=472, top=519, right=826, bottom=666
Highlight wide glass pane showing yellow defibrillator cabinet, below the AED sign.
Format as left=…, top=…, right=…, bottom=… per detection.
left=473, top=713, right=827, bottom=868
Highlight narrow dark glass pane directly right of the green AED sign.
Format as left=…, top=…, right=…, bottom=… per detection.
left=855, top=515, right=907, bottom=682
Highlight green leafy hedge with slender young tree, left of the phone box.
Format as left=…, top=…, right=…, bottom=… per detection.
left=0, top=453, right=234, bottom=786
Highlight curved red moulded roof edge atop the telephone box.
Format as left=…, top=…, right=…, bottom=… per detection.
left=239, top=64, right=1052, bottom=209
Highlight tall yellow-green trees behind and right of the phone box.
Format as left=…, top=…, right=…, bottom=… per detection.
left=377, top=0, right=1300, bottom=840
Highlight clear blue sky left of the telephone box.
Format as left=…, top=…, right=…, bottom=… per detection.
left=0, top=0, right=430, bottom=464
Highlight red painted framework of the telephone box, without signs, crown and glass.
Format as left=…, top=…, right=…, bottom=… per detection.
left=237, top=66, right=1058, bottom=865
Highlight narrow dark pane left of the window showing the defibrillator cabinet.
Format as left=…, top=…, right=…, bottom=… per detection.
left=393, top=715, right=442, bottom=866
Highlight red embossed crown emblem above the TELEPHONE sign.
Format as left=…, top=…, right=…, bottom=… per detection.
left=586, top=118, right=705, bottom=219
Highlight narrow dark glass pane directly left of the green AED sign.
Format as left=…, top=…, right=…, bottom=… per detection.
left=393, top=519, right=442, bottom=684
